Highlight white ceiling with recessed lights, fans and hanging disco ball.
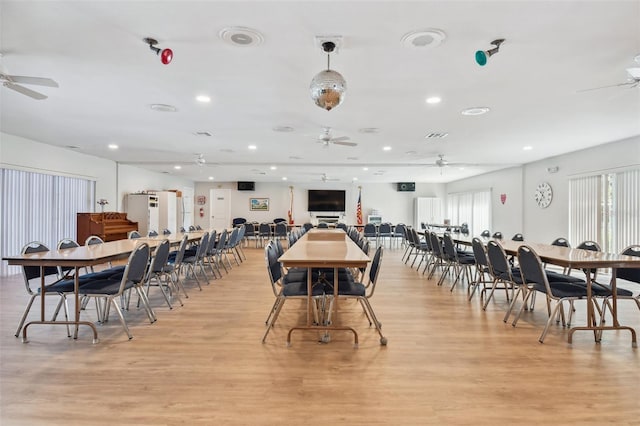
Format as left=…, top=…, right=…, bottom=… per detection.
left=0, top=0, right=640, bottom=183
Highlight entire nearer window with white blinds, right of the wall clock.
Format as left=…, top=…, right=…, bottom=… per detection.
left=569, top=169, right=640, bottom=253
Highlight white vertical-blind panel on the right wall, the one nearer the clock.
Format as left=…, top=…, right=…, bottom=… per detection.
left=568, top=175, right=609, bottom=251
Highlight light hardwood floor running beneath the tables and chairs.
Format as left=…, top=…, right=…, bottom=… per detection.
left=0, top=241, right=640, bottom=426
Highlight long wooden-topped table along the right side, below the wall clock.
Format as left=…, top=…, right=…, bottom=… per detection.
left=451, top=234, right=640, bottom=348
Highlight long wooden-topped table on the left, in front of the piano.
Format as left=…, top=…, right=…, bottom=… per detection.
left=2, top=232, right=202, bottom=343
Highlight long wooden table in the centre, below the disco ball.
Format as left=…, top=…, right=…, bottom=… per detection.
left=279, top=229, right=369, bottom=347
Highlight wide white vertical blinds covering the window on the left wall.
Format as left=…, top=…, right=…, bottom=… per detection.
left=0, top=169, right=95, bottom=276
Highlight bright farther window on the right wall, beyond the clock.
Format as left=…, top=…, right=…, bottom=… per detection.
left=447, top=190, right=491, bottom=235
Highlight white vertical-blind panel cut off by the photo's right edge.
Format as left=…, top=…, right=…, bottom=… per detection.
left=611, top=170, right=640, bottom=253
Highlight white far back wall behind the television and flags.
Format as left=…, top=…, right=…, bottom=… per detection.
left=195, top=182, right=445, bottom=227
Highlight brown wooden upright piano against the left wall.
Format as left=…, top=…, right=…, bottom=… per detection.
left=77, top=212, right=138, bottom=244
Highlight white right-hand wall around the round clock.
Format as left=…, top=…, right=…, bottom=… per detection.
left=446, top=136, right=640, bottom=245
